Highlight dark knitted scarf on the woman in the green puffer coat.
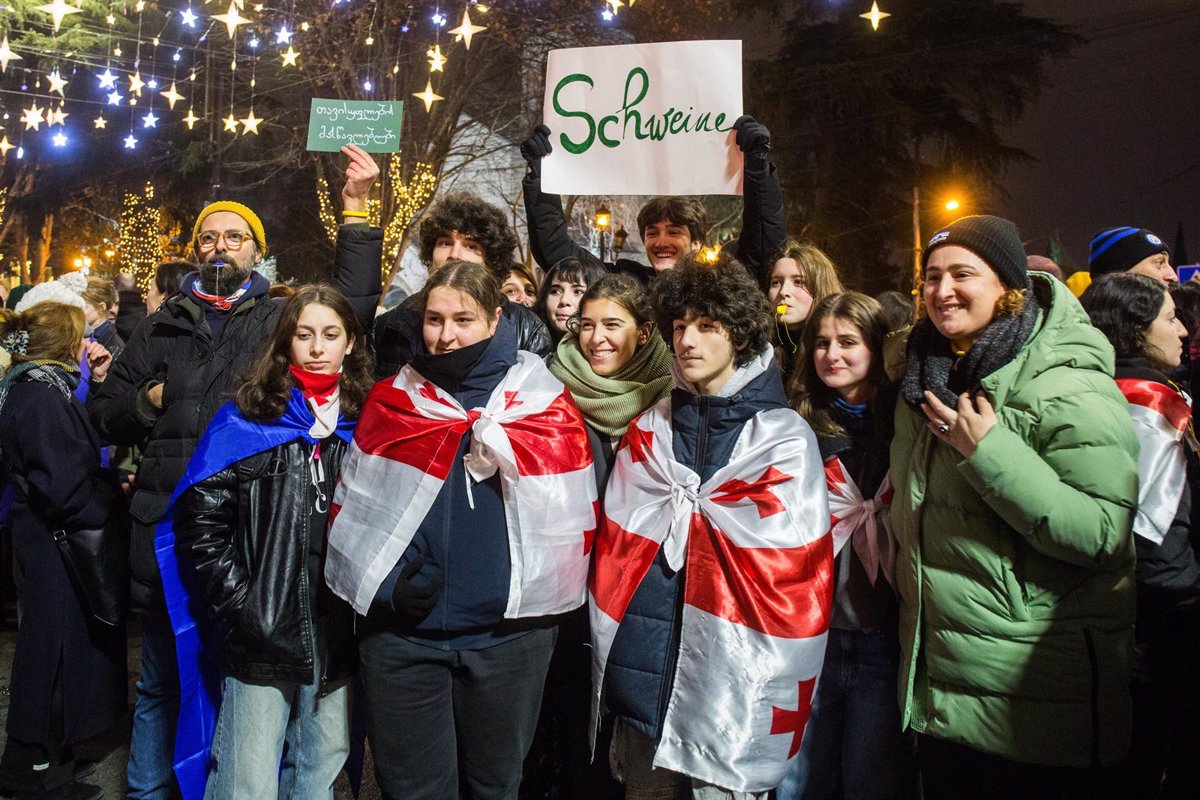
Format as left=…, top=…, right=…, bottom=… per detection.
left=904, top=291, right=1040, bottom=409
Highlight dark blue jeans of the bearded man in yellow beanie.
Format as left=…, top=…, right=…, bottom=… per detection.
left=126, top=624, right=179, bottom=800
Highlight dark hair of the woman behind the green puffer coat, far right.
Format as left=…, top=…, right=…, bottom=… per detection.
left=1079, top=272, right=1166, bottom=359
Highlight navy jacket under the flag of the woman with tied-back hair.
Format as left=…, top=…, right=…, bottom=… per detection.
left=376, top=317, right=517, bottom=649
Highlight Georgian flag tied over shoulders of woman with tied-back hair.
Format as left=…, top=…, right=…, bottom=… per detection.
left=325, top=350, right=596, bottom=619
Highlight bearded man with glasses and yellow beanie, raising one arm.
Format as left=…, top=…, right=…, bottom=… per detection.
left=88, top=146, right=383, bottom=799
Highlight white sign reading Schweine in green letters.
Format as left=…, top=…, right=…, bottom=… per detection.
left=541, top=41, right=742, bottom=194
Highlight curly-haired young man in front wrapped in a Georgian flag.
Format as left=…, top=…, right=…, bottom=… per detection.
left=590, top=255, right=833, bottom=800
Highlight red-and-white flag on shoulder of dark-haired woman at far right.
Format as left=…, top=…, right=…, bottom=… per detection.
left=1117, top=378, right=1194, bottom=545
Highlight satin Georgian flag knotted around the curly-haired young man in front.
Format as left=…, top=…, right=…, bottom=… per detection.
left=589, top=398, right=833, bottom=792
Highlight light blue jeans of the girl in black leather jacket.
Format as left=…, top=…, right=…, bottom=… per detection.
left=204, top=676, right=350, bottom=800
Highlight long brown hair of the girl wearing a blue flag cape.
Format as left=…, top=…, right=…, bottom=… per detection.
left=234, top=283, right=374, bottom=422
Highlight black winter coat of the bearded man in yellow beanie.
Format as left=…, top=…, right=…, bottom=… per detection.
left=88, top=225, right=383, bottom=618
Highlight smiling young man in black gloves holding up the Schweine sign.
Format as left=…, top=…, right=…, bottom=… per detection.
left=521, top=115, right=787, bottom=283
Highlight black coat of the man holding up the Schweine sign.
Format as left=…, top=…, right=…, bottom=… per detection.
left=522, top=149, right=787, bottom=284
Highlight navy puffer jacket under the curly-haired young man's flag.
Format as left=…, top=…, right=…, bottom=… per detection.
left=605, top=352, right=787, bottom=741
